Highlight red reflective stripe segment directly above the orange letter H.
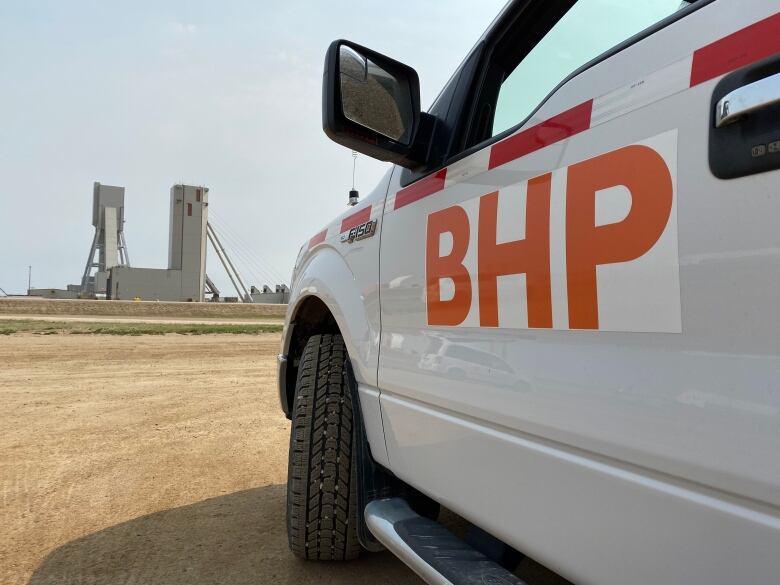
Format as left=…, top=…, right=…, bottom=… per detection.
left=488, top=100, right=593, bottom=169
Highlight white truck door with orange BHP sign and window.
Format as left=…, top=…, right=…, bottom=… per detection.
left=379, top=0, right=780, bottom=584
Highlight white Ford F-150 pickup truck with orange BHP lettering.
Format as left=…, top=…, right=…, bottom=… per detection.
left=279, top=0, right=780, bottom=585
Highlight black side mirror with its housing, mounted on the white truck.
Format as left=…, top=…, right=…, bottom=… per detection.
left=322, top=40, right=432, bottom=168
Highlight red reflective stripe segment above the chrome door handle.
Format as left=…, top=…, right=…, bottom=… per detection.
left=691, top=12, right=780, bottom=87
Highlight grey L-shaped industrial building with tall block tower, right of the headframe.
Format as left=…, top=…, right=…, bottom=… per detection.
left=108, top=185, right=209, bottom=302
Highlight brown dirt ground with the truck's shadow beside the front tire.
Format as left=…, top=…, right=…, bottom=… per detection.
left=0, top=334, right=420, bottom=585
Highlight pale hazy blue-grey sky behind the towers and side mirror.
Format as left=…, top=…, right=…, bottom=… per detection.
left=0, top=0, right=504, bottom=294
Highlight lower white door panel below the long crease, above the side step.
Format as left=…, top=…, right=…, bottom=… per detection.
left=381, top=393, right=780, bottom=585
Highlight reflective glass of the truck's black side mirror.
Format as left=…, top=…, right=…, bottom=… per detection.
left=339, top=45, right=414, bottom=145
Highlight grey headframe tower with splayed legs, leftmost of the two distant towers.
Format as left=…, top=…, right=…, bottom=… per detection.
left=81, top=182, right=130, bottom=297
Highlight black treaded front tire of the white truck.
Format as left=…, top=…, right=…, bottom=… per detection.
left=287, top=335, right=360, bottom=561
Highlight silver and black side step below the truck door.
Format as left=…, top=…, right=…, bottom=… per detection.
left=365, top=498, right=526, bottom=585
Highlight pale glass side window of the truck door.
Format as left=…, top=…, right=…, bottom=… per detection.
left=490, top=0, right=695, bottom=139
